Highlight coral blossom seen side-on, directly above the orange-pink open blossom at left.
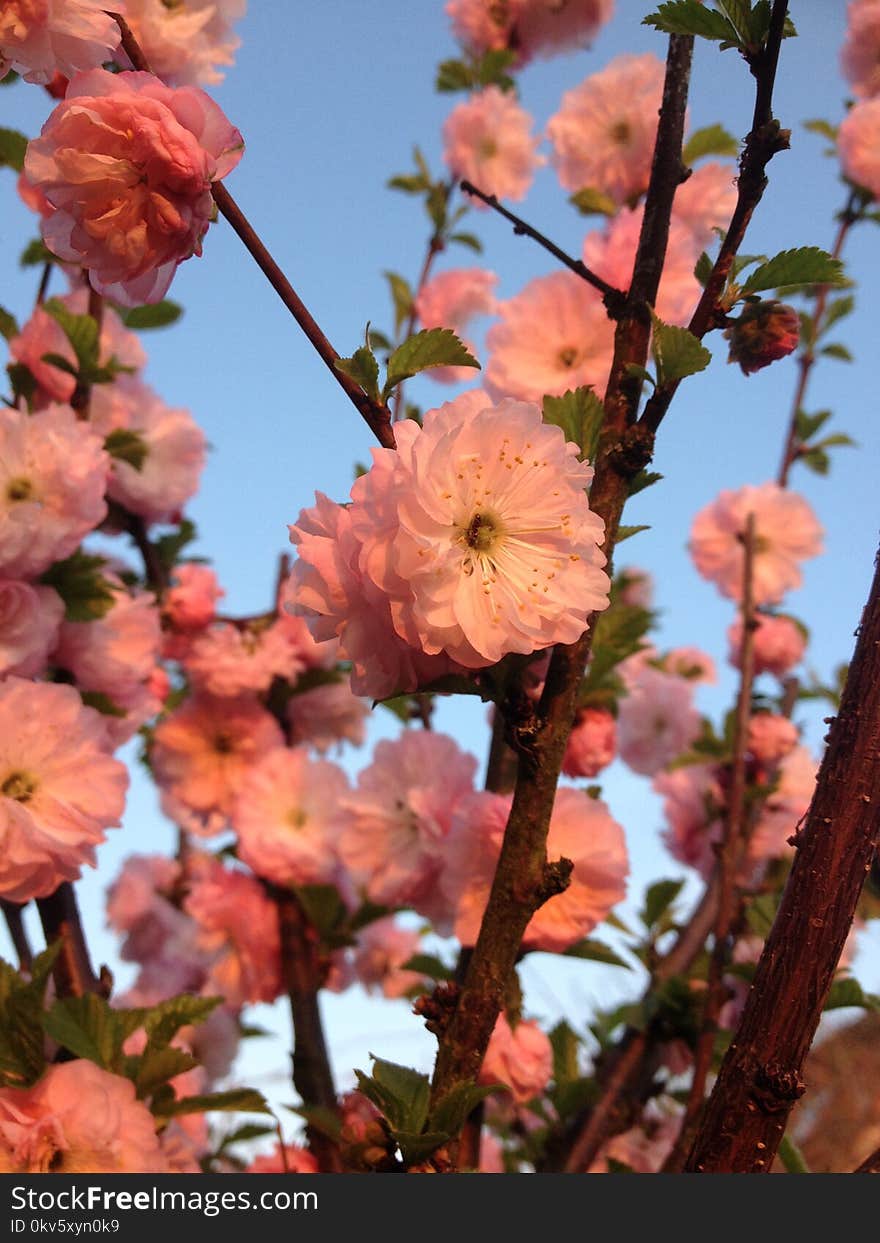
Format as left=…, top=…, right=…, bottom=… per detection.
left=181, top=622, right=303, bottom=699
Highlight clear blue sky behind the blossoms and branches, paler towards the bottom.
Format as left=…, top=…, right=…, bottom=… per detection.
left=0, top=0, right=880, bottom=1138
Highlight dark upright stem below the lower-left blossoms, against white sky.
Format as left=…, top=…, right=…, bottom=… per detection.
left=270, top=886, right=342, bottom=1173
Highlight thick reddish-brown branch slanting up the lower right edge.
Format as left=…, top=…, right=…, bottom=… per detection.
left=686, top=541, right=880, bottom=1173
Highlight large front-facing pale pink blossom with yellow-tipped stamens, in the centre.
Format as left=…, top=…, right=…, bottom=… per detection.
left=351, top=401, right=609, bottom=669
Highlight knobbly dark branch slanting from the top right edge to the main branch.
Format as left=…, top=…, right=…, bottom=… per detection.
left=640, top=0, right=789, bottom=433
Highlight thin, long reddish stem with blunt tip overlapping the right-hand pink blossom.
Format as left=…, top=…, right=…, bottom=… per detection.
left=664, top=513, right=756, bottom=1173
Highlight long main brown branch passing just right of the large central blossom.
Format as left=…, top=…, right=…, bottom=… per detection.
left=431, top=36, right=694, bottom=1128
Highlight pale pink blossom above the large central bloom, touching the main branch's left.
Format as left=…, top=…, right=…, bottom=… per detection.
left=484, top=272, right=611, bottom=403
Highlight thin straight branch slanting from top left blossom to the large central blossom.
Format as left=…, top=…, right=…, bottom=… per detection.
left=109, top=12, right=395, bottom=449
